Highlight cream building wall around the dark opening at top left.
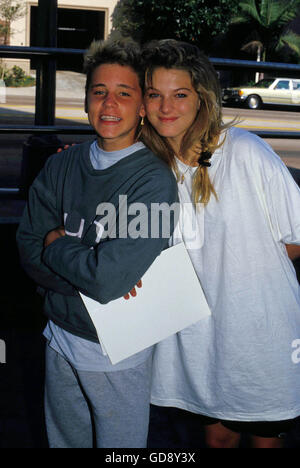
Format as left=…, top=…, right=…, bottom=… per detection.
left=5, top=0, right=118, bottom=72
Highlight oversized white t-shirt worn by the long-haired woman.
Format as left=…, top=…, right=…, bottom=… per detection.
left=152, top=128, right=300, bottom=421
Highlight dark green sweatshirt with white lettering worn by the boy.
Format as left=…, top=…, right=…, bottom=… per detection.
left=17, top=142, right=178, bottom=342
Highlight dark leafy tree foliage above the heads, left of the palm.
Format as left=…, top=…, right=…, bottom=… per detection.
left=112, top=0, right=238, bottom=49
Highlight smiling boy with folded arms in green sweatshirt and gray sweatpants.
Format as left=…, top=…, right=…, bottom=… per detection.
left=17, top=38, right=177, bottom=448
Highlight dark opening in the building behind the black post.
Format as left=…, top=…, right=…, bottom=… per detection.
left=30, top=6, right=105, bottom=72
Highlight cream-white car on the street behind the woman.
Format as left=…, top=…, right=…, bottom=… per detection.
left=222, top=78, right=300, bottom=109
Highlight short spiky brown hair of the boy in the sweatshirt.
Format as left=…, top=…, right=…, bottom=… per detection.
left=84, top=39, right=145, bottom=95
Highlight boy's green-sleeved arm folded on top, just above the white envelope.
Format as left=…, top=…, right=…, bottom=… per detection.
left=43, top=178, right=179, bottom=304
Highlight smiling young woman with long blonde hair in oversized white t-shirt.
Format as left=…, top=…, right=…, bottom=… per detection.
left=143, top=40, right=300, bottom=448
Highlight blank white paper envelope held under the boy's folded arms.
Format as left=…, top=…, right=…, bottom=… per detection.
left=81, top=243, right=211, bottom=364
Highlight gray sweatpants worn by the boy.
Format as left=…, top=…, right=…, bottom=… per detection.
left=45, top=345, right=152, bottom=448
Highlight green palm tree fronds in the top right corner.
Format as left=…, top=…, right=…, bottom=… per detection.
left=231, top=0, right=300, bottom=61
